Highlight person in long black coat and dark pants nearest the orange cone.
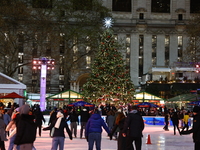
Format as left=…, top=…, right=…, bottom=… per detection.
left=122, top=106, right=144, bottom=150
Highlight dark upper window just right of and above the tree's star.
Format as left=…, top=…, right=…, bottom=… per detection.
left=112, top=0, right=131, bottom=12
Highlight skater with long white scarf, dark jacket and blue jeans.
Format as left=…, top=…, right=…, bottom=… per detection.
left=43, top=111, right=73, bottom=150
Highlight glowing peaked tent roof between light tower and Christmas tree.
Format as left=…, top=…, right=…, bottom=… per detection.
left=46, top=90, right=83, bottom=99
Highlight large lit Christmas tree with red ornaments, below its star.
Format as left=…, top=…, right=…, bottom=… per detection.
left=83, top=29, right=135, bottom=104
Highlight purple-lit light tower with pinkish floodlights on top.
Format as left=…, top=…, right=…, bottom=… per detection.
left=33, top=57, right=55, bottom=111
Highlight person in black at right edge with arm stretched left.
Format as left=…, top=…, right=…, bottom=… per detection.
left=181, top=106, right=200, bottom=150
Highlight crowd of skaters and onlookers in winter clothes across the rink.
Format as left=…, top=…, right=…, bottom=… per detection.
left=0, top=104, right=200, bottom=150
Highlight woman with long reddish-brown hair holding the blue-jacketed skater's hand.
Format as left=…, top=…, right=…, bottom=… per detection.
left=110, top=112, right=133, bottom=150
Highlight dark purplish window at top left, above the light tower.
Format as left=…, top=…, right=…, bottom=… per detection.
left=32, top=0, right=52, bottom=8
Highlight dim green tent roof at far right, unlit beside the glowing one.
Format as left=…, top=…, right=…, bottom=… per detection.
left=166, top=94, right=197, bottom=101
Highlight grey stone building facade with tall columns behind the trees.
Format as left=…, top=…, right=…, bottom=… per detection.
left=6, top=0, right=200, bottom=93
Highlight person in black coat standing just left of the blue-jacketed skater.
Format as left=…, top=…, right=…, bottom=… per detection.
left=80, top=108, right=90, bottom=139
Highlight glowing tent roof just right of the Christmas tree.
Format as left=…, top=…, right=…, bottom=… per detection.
left=134, top=92, right=164, bottom=100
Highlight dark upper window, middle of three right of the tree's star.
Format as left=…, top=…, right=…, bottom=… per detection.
left=151, top=0, right=170, bottom=13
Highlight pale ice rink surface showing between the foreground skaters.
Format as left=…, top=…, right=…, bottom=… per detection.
left=5, top=126, right=194, bottom=150
